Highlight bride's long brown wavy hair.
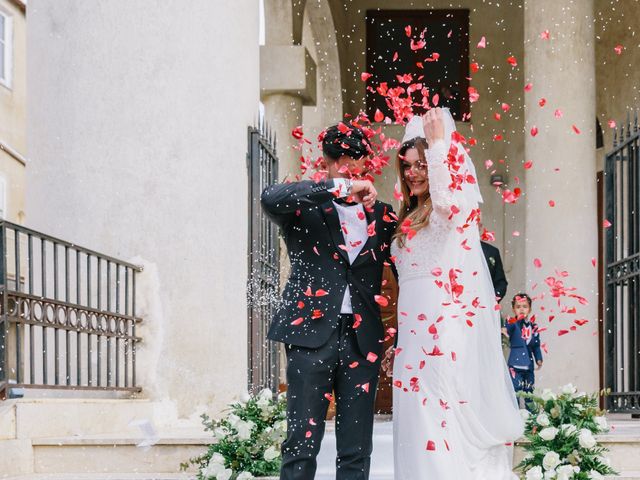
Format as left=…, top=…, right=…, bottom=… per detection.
left=393, top=137, right=433, bottom=248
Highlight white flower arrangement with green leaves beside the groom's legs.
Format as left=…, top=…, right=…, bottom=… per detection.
left=181, top=389, right=287, bottom=480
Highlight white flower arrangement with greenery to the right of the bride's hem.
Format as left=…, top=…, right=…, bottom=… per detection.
left=517, top=384, right=616, bottom=480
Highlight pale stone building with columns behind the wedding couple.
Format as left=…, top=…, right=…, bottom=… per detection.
left=0, top=0, right=640, bottom=475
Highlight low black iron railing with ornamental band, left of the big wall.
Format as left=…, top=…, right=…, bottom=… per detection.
left=0, top=221, right=142, bottom=396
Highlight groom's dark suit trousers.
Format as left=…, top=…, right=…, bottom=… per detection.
left=280, top=315, right=381, bottom=480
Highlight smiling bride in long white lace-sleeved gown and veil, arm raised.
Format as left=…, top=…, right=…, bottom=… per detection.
left=392, top=108, right=523, bottom=480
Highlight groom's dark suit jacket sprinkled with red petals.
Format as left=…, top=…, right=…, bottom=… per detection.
left=261, top=180, right=396, bottom=356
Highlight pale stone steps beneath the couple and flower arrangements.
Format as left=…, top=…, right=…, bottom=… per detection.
left=0, top=399, right=640, bottom=480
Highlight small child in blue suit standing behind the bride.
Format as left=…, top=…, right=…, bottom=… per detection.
left=503, top=293, right=542, bottom=409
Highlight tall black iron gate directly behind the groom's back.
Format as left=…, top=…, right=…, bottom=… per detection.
left=247, top=123, right=280, bottom=391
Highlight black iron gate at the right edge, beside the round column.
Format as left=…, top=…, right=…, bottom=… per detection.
left=604, top=113, right=640, bottom=414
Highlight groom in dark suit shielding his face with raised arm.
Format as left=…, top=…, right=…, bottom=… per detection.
left=262, top=124, right=396, bottom=480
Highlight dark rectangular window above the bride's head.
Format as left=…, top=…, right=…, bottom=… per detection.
left=367, top=10, right=469, bottom=121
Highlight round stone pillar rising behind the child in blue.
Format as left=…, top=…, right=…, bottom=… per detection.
left=524, top=0, right=599, bottom=392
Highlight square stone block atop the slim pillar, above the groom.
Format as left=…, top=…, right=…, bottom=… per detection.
left=260, top=45, right=317, bottom=105
